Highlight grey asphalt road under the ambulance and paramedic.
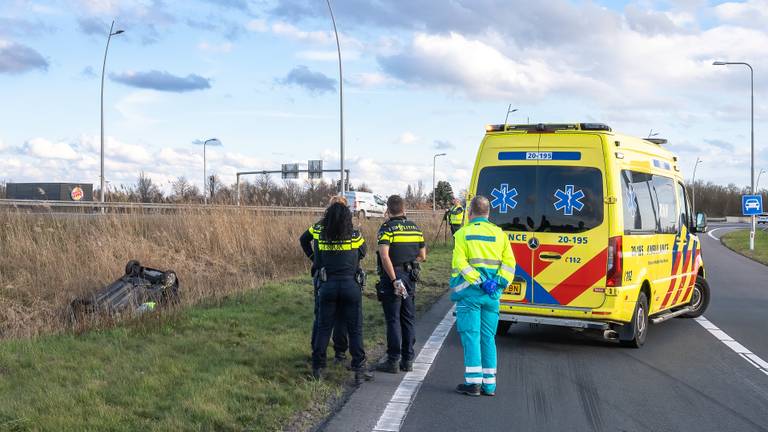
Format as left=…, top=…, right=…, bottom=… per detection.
left=327, top=225, right=768, bottom=432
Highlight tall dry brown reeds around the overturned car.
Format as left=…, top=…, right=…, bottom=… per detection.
left=0, top=210, right=443, bottom=338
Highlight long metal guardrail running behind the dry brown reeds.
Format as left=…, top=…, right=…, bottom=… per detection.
left=0, top=199, right=443, bottom=218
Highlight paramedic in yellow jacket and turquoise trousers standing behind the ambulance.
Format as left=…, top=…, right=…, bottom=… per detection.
left=450, top=195, right=515, bottom=396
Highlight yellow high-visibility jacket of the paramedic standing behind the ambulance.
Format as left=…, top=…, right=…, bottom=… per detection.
left=450, top=218, right=516, bottom=301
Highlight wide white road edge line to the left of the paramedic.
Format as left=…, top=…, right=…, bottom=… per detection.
left=373, top=307, right=456, bottom=432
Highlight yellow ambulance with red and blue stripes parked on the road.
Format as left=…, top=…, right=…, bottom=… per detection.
left=468, top=123, right=709, bottom=347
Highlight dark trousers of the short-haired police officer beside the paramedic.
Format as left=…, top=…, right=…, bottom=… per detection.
left=381, top=271, right=416, bottom=362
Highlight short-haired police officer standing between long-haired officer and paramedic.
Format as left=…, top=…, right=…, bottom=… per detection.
left=376, top=195, right=427, bottom=373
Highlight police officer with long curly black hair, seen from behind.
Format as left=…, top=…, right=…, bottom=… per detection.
left=312, top=202, right=373, bottom=384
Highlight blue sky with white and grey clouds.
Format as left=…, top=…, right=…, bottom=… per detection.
left=0, top=0, right=768, bottom=195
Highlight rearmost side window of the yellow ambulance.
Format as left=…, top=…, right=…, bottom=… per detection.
left=621, top=170, right=658, bottom=234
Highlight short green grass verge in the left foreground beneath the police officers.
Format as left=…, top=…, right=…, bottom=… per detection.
left=0, top=248, right=450, bottom=431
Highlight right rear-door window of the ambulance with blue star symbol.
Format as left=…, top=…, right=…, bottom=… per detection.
left=536, top=166, right=604, bottom=233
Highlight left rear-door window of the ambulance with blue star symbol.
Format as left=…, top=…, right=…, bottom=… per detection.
left=476, top=166, right=537, bottom=231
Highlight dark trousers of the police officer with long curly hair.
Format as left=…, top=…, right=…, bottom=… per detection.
left=312, top=278, right=365, bottom=369
